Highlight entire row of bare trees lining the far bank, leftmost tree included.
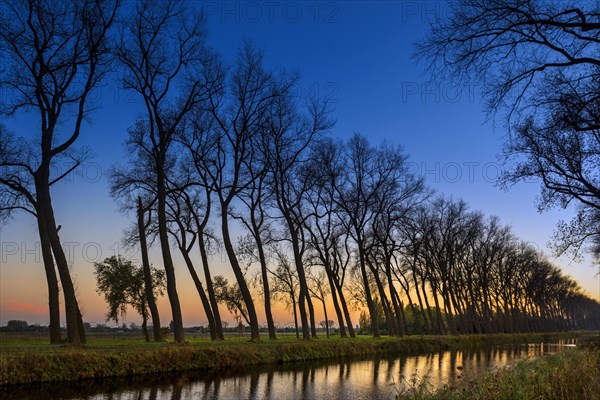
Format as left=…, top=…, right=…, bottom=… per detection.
left=0, top=1, right=600, bottom=343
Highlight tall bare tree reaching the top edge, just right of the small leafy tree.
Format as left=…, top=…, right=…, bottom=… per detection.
left=117, top=0, right=212, bottom=343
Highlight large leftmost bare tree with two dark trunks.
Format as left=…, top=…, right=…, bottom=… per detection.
left=0, top=0, right=119, bottom=344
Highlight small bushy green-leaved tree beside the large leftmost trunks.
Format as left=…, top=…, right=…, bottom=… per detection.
left=94, top=256, right=166, bottom=341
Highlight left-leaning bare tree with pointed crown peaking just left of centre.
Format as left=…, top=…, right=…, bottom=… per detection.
left=197, top=43, right=298, bottom=340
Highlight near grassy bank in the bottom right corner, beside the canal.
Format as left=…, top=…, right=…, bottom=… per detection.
left=396, top=336, right=600, bottom=400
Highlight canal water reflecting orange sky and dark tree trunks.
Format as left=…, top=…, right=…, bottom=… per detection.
left=0, top=341, right=572, bottom=400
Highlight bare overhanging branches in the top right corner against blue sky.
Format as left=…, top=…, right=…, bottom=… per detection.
left=417, top=0, right=600, bottom=117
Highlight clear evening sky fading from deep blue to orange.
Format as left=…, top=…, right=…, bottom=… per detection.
left=0, top=1, right=600, bottom=326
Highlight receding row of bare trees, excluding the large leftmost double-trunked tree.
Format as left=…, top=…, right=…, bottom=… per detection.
left=105, top=1, right=600, bottom=341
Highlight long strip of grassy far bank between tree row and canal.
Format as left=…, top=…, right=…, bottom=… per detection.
left=0, top=332, right=592, bottom=385
